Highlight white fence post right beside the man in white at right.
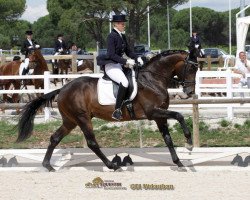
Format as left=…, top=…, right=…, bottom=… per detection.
left=226, top=70, right=234, bottom=120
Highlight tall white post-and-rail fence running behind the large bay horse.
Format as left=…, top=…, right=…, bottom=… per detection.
left=0, top=71, right=250, bottom=120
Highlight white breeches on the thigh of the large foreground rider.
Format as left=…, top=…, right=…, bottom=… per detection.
left=105, top=63, right=128, bottom=88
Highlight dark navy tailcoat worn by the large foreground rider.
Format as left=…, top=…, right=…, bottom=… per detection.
left=97, top=29, right=137, bottom=66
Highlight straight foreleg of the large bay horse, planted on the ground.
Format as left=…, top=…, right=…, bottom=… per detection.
left=155, top=120, right=183, bottom=167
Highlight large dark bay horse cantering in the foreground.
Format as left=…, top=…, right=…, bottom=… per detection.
left=16, top=52, right=197, bottom=171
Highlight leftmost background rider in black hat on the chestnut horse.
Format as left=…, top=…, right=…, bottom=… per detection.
left=20, top=30, right=40, bottom=75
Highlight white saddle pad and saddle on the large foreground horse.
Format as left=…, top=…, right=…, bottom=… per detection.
left=97, top=68, right=137, bottom=105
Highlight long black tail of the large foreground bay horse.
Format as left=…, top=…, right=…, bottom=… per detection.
left=16, top=89, right=60, bottom=142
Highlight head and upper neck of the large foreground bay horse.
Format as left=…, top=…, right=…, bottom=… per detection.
left=141, top=50, right=198, bottom=96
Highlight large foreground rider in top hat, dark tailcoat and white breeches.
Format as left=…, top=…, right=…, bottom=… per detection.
left=98, top=15, right=143, bottom=120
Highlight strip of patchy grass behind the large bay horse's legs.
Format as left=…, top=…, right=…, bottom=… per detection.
left=0, top=118, right=250, bottom=149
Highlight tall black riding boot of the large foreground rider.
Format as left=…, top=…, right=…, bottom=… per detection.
left=112, top=83, right=127, bottom=120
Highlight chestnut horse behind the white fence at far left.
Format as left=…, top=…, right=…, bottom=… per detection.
left=0, top=48, right=49, bottom=103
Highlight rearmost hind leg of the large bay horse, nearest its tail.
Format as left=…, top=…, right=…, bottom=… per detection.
left=43, top=121, right=76, bottom=171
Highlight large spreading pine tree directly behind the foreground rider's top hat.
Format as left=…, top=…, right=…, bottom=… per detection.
left=47, top=0, right=187, bottom=47
